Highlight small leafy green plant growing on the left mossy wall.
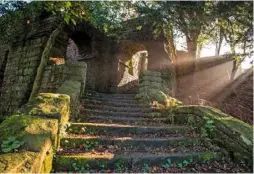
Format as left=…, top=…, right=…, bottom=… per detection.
left=1, top=136, right=24, bottom=153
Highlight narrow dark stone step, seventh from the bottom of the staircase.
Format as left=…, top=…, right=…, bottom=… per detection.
left=81, top=99, right=152, bottom=108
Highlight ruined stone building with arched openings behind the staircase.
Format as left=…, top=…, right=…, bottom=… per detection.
left=0, top=13, right=242, bottom=115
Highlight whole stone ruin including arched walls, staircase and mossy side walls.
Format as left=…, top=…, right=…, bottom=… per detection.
left=0, top=14, right=253, bottom=173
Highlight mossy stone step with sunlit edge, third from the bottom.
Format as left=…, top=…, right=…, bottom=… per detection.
left=67, top=123, right=192, bottom=136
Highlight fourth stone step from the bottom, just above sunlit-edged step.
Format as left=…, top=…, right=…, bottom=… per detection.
left=84, top=115, right=167, bottom=125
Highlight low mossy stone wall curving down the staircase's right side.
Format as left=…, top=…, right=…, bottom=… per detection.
left=164, top=105, right=253, bottom=166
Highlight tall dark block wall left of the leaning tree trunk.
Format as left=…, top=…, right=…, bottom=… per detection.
left=0, top=18, right=58, bottom=115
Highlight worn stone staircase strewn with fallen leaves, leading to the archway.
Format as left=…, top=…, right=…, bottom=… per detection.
left=54, top=92, right=229, bottom=173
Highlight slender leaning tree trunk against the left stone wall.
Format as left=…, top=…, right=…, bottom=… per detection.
left=29, top=23, right=63, bottom=101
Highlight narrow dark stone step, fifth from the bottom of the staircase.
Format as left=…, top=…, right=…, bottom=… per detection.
left=82, top=109, right=156, bottom=118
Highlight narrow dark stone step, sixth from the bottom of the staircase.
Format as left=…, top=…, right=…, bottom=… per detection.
left=85, top=103, right=156, bottom=112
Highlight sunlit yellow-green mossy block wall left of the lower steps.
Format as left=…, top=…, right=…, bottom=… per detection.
left=0, top=93, right=70, bottom=173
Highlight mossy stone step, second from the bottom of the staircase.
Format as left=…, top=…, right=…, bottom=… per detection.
left=61, top=136, right=202, bottom=150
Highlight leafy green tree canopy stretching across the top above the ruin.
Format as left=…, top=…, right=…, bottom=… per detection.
left=0, top=1, right=253, bottom=60
